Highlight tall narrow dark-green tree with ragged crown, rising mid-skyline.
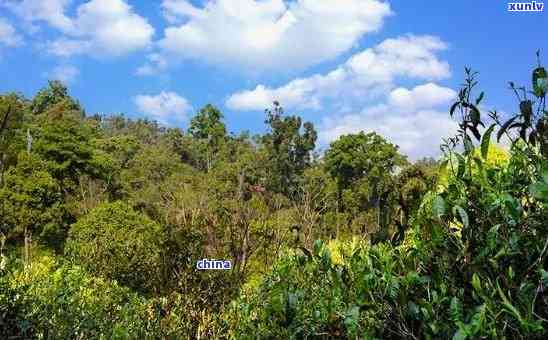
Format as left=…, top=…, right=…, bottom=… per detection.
left=261, top=102, right=318, bottom=196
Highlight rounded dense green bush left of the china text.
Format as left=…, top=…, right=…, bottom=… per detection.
left=65, top=202, right=163, bottom=292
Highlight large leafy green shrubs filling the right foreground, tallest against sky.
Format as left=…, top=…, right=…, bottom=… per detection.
left=225, top=59, right=548, bottom=339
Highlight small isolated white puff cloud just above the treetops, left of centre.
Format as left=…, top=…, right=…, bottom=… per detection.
left=133, top=91, right=192, bottom=124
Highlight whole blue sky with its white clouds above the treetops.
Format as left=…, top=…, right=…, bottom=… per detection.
left=0, top=0, right=548, bottom=159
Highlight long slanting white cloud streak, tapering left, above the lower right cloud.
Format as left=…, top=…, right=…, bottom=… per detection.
left=226, top=35, right=450, bottom=110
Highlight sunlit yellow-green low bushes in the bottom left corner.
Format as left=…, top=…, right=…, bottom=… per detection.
left=0, top=256, right=166, bottom=339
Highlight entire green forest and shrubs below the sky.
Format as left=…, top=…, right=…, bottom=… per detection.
left=0, top=53, right=548, bottom=339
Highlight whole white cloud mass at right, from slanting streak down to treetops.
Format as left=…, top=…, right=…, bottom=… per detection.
left=226, top=35, right=457, bottom=159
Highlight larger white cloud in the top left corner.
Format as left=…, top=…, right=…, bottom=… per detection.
left=6, top=0, right=154, bottom=56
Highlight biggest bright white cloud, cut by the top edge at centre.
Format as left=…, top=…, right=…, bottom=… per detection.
left=159, top=0, right=391, bottom=71
